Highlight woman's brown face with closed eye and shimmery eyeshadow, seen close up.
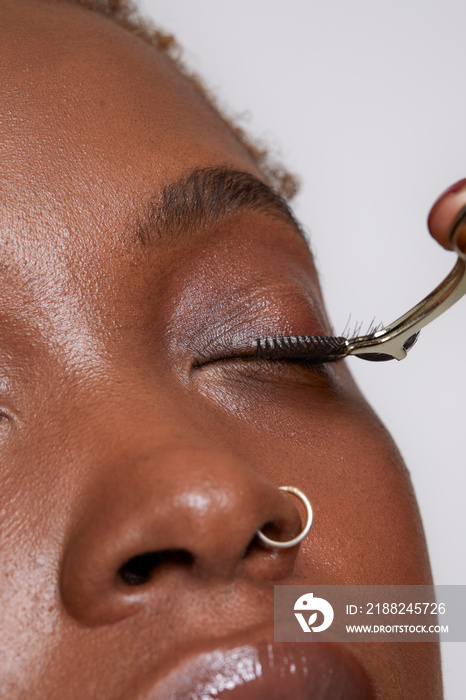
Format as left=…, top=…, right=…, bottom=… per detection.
left=0, top=0, right=441, bottom=700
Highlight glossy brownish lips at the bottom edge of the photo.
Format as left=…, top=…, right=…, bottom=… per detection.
left=134, top=630, right=374, bottom=700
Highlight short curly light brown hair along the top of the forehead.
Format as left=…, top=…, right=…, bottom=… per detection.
left=65, top=0, right=299, bottom=200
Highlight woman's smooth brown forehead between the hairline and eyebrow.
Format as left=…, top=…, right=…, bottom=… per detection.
left=0, top=0, right=259, bottom=252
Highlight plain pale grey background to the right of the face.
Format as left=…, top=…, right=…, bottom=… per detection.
left=140, top=0, right=466, bottom=700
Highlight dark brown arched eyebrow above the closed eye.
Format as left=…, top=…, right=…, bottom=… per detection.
left=132, top=168, right=307, bottom=248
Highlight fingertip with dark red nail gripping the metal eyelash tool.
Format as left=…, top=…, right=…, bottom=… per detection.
left=427, top=179, right=466, bottom=252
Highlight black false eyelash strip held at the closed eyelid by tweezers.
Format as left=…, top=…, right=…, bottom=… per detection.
left=254, top=335, right=348, bottom=363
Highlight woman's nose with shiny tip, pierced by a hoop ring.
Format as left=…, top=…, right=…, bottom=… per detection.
left=60, top=440, right=301, bottom=626
